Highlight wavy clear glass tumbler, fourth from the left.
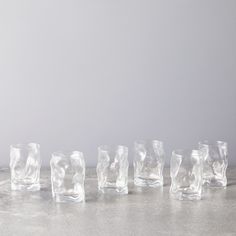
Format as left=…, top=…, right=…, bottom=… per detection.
left=133, top=140, right=165, bottom=187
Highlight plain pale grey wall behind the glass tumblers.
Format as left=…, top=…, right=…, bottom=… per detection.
left=0, top=0, right=236, bottom=166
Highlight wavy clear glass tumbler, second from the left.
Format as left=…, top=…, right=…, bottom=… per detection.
left=50, top=151, right=85, bottom=202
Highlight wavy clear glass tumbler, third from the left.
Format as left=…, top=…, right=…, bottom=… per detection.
left=97, top=146, right=129, bottom=194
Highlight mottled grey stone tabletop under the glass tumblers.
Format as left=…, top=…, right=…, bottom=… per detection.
left=0, top=168, right=236, bottom=236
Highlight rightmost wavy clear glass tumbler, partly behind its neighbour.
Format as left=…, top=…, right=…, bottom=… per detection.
left=199, top=141, right=228, bottom=187
